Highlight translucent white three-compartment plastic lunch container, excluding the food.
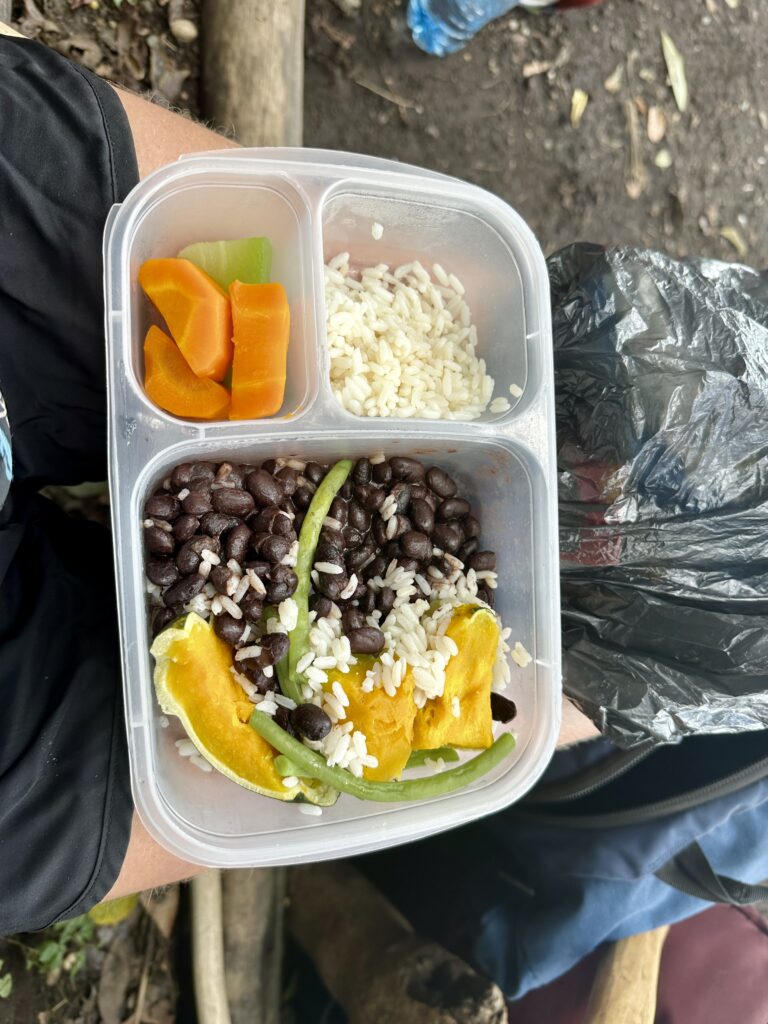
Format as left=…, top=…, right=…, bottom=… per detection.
left=104, top=150, right=560, bottom=867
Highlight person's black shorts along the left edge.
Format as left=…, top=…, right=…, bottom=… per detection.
left=0, top=36, right=138, bottom=935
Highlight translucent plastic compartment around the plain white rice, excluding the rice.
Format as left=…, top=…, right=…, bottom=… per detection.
left=321, top=179, right=541, bottom=424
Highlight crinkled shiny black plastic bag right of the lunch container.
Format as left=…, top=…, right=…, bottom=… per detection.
left=549, top=245, right=768, bottom=748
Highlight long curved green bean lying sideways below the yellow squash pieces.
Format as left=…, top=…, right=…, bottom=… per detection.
left=250, top=708, right=515, bottom=804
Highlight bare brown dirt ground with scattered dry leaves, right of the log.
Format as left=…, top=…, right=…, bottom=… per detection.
left=304, top=0, right=768, bottom=266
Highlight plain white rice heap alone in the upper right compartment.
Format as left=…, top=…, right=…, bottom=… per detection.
left=326, top=253, right=494, bottom=420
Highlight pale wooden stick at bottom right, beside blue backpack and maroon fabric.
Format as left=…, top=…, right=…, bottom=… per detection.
left=585, top=928, right=669, bottom=1024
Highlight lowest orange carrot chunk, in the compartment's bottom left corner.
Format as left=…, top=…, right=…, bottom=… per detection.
left=144, top=327, right=229, bottom=420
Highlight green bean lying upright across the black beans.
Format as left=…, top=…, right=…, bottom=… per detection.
left=281, top=459, right=352, bottom=703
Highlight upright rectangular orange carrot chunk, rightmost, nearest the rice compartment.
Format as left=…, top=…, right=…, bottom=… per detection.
left=229, top=281, right=291, bottom=420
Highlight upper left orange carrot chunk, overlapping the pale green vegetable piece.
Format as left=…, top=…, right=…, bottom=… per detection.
left=138, top=259, right=232, bottom=381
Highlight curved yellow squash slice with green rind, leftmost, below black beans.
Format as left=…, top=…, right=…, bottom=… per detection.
left=152, top=613, right=337, bottom=805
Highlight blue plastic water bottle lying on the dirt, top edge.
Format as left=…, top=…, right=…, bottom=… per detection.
left=408, top=0, right=556, bottom=57
